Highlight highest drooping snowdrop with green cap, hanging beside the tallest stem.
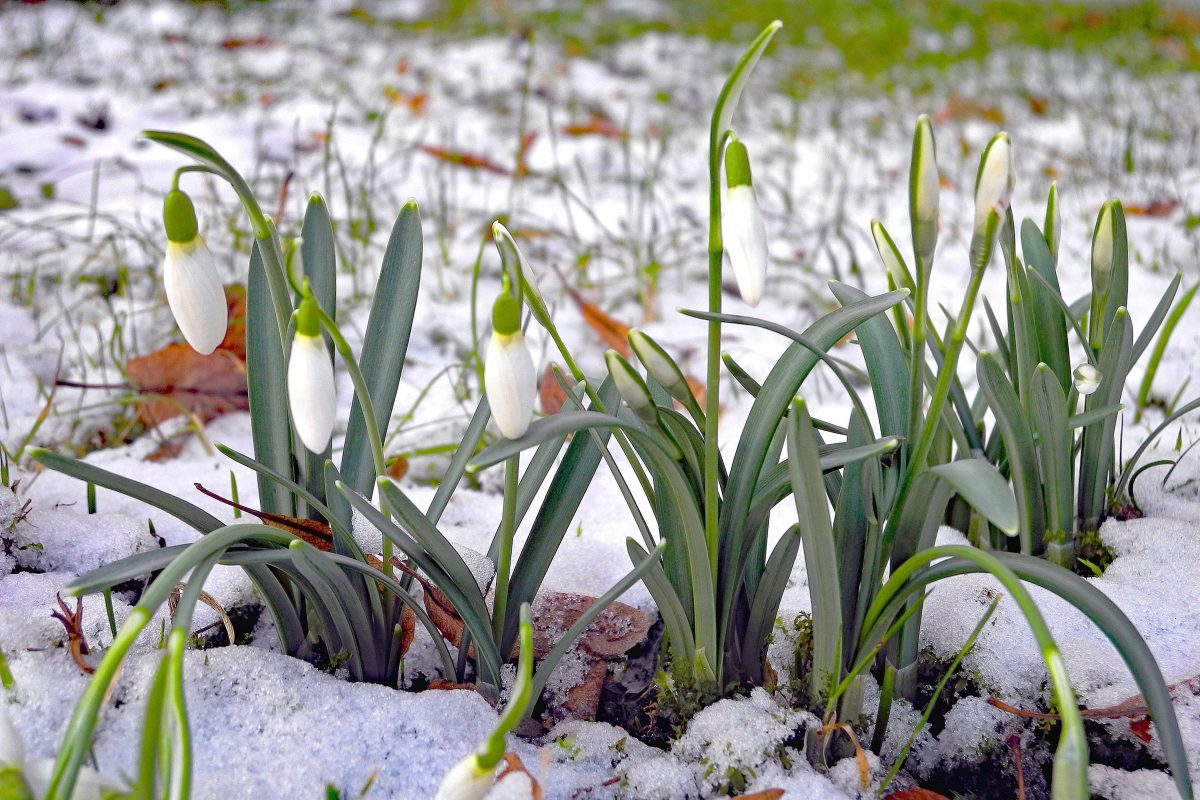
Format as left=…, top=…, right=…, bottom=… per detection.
left=721, top=139, right=767, bottom=306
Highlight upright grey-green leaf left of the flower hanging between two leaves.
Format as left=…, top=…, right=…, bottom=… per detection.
left=246, top=241, right=296, bottom=517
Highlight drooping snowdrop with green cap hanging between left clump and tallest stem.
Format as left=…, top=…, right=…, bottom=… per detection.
left=482, top=289, right=538, bottom=441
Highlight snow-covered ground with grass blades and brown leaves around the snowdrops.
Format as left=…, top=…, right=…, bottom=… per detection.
left=0, top=2, right=1200, bottom=800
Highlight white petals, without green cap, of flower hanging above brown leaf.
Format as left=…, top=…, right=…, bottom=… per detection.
left=162, top=236, right=229, bottom=355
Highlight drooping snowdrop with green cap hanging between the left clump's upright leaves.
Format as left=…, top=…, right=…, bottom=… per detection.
left=288, top=296, right=337, bottom=453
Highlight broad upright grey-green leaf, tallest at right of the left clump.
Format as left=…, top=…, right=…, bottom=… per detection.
left=330, top=200, right=422, bottom=522
